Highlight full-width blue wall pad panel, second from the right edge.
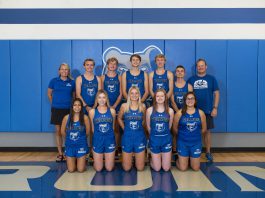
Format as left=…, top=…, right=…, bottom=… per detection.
left=227, top=40, right=258, bottom=132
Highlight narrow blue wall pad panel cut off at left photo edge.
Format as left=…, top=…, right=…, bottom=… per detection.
left=0, top=41, right=11, bottom=131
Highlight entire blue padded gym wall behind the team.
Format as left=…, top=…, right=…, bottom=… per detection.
left=0, top=40, right=265, bottom=132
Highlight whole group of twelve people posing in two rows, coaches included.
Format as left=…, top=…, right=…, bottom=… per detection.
left=48, top=54, right=219, bottom=172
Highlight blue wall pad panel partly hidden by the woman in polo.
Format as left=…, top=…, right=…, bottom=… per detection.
left=41, top=40, right=72, bottom=131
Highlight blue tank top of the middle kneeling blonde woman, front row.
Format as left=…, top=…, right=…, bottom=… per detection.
left=124, top=109, right=144, bottom=133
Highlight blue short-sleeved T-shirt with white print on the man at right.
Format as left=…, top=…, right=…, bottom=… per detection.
left=188, top=74, right=219, bottom=114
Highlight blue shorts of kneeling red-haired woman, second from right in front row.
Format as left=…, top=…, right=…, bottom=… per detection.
left=149, top=135, right=172, bottom=154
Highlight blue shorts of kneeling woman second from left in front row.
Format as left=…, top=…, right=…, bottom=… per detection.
left=92, top=135, right=116, bottom=153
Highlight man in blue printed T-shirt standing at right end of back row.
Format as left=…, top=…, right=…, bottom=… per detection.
left=188, top=59, right=220, bottom=161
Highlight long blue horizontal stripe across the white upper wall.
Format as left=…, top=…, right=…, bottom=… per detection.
left=0, top=8, right=265, bottom=24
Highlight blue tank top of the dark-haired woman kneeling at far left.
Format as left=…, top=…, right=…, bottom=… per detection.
left=65, top=115, right=87, bottom=146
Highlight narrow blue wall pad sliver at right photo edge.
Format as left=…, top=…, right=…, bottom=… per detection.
left=258, top=41, right=265, bottom=132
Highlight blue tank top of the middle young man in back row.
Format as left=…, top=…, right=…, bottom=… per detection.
left=126, top=71, right=145, bottom=97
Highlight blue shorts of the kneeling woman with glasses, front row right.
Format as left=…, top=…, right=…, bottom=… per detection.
left=178, top=141, right=202, bottom=158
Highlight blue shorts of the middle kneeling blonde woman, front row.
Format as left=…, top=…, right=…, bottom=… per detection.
left=121, top=131, right=146, bottom=153
